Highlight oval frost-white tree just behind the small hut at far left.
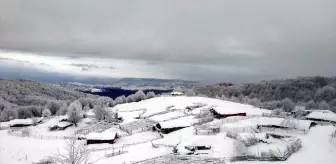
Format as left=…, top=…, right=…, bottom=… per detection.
left=67, top=100, right=83, bottom=126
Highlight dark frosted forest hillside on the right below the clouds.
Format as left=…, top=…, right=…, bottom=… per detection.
left=195, top=76, right=336, bottom=111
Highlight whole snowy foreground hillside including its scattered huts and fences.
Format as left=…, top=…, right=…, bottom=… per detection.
left=0, top=96, right=336, bottom=164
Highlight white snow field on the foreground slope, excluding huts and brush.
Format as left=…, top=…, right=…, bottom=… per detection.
left=0, top=96, right=336, bottom=164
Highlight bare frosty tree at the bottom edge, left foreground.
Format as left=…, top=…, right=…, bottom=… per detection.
left=50, top=138, right=90, bottom=164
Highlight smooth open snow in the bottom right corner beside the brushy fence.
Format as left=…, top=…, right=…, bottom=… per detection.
left=234, top=126, right=336, bottom=164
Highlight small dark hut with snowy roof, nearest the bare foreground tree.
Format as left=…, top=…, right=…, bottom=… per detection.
left=83, top=131, right=119, bottom=145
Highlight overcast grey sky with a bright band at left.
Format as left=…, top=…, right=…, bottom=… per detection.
left=0, top=0, right=336, bottom=82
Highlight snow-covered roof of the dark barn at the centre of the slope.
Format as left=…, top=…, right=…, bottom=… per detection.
left=160, top=116, right=198, bottom=128
